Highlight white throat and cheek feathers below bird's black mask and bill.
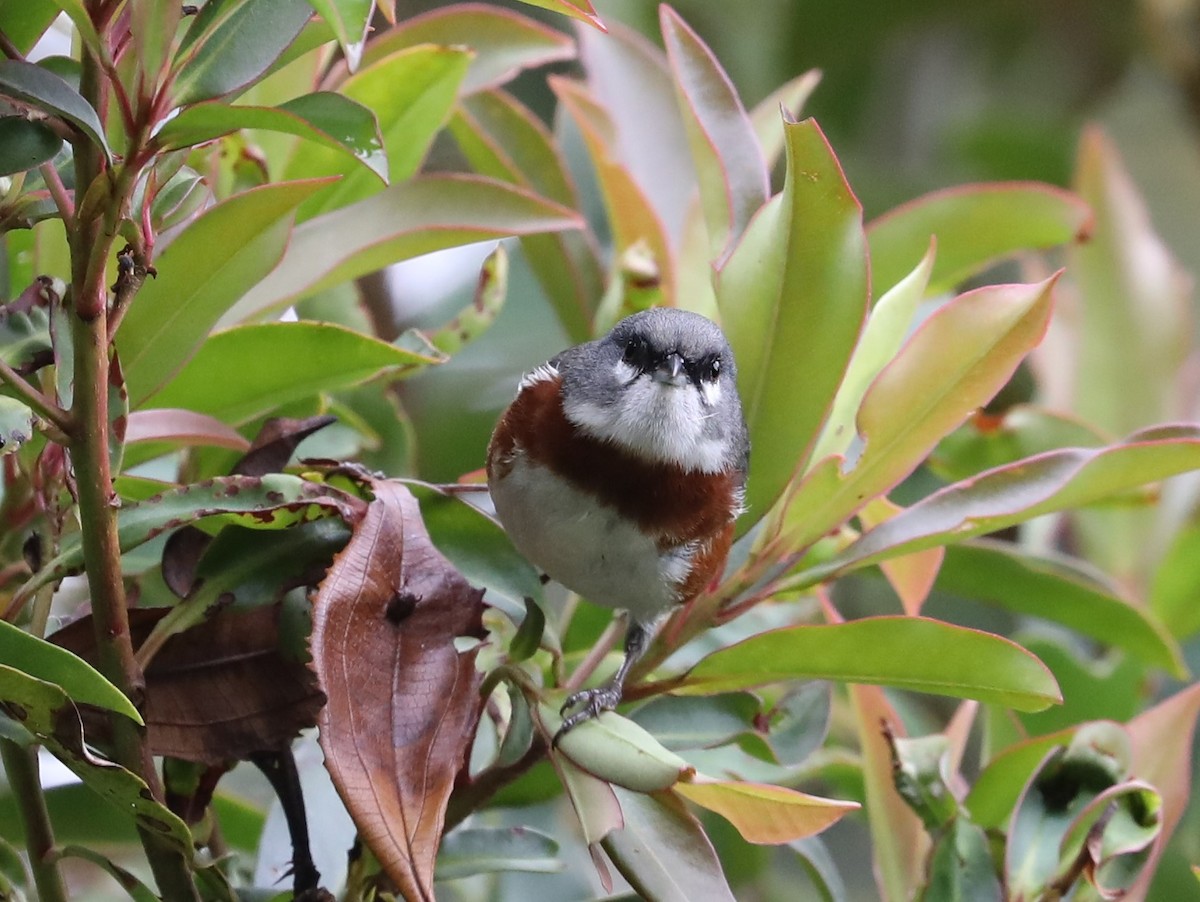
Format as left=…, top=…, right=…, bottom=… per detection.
left=563, top=361, right=728, bottom=473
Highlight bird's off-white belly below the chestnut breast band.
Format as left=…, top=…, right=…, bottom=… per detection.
left=491, top=453, right=691, bottom=623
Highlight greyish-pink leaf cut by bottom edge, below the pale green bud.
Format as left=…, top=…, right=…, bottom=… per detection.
left=604, top=789, right=734, bottom=902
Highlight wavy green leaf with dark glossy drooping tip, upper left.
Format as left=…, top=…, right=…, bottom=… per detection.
left=157, top=91, right=388, bottom=185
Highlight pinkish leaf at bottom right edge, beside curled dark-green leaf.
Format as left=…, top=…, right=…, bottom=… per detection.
left=1128, top=684, right=1200, bottom=898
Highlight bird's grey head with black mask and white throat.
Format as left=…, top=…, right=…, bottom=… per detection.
left=556, top=307, right=748, bottom=473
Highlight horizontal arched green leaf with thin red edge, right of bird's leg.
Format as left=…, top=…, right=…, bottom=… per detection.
left=673, top=617, right=1062, bottom=711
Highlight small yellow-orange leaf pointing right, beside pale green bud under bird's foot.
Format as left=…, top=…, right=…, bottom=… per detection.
left=674, top=777, right=859, bottom=846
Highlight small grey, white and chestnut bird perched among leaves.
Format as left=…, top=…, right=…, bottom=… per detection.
left=487, top=308, right=750, bottom=741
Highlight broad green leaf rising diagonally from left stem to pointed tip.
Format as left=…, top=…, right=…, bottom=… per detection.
left=116, top=180, right=328, bottom=407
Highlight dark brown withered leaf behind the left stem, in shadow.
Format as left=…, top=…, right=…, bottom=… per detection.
left=50, top=605, right=323, bottom=765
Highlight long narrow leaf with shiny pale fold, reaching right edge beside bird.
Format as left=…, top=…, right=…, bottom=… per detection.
left=797, top=426, right=1200, bottom=585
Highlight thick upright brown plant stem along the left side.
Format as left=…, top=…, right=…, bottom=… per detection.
left=70, top=35, right=199, bottom=902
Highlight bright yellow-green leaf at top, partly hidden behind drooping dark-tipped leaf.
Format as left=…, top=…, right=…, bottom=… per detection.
left=284, top=46, right=470, bottom=221
